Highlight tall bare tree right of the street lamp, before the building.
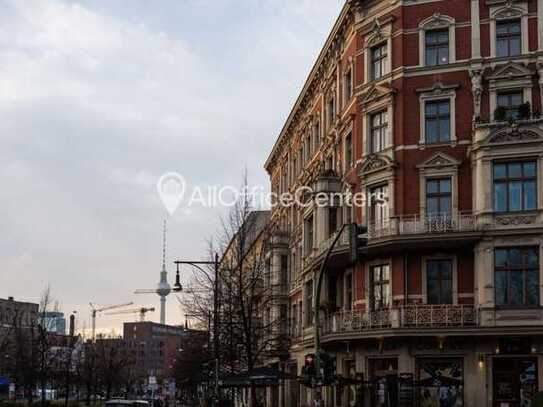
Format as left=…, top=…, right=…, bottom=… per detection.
left=180, top=178, right=286, bottom=405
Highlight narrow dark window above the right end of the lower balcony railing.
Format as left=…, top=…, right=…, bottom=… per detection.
left=426, top=260, right=453, bottom=304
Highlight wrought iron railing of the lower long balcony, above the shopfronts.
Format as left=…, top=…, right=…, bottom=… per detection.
left=323, top=304, right=478, bottom=335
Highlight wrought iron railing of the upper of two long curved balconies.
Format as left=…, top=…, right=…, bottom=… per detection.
left=368, top=213, right=478, bottom=239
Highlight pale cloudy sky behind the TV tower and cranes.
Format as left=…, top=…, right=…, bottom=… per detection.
left=0, top=0, right=344, bottom=333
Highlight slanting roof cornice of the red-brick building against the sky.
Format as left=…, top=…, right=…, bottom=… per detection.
left=264, top=0, right=353, bottom=171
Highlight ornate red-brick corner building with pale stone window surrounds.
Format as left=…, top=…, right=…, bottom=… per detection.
left=265, top=0, right=543, bottom=407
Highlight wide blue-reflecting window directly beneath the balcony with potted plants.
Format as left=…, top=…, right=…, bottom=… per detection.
left=494, top=161, right=537, bottom=212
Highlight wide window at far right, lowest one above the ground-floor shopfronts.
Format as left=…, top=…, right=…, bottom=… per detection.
left=494, top=247, right=539, bottom=306
